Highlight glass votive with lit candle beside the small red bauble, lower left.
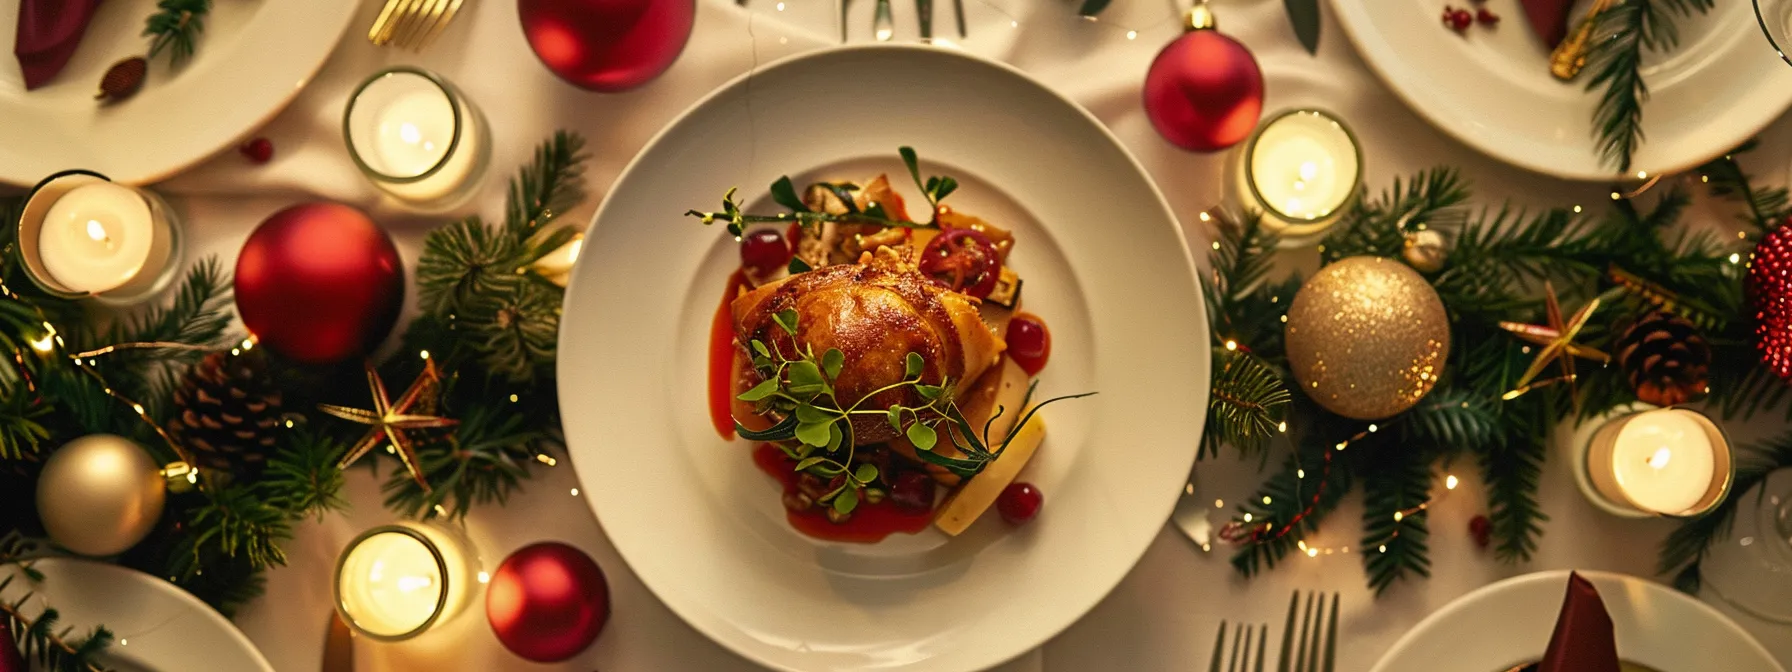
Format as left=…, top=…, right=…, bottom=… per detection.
left=332, top=521, right=478, bottom=642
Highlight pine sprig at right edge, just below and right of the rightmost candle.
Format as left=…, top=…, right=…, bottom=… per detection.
left=1656, top=434, right=1792, bottom=593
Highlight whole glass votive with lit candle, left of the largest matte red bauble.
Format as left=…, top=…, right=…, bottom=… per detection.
left=7, top=170, right=181, bottom=306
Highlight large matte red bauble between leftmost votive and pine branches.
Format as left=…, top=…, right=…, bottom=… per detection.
left=237, top=202, right=405, bottom=364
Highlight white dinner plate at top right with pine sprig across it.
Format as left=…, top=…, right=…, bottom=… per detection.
left=1331, top=0, right=1792, bottom=179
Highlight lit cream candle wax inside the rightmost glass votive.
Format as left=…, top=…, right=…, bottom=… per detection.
left=1607, top=409, right=1719, bottom=514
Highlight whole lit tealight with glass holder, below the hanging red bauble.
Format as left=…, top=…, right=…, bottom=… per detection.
left=1233, top=109, right=1362, bottom=242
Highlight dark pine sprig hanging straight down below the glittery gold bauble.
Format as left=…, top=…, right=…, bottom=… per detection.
left=1362, top=443, right=1432, bottom=595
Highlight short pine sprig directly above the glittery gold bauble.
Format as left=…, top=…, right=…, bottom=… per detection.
left=1319, top=167, right=1469, bottom=263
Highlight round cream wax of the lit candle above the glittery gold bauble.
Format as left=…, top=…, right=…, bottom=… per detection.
left=1245, top=111, right=1362, bottom=220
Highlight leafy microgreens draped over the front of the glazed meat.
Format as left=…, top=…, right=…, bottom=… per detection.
left=735, top=310, right=1095, bottom=514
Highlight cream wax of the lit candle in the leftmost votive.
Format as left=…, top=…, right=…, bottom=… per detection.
left=38, top=181, right=168, bottom=292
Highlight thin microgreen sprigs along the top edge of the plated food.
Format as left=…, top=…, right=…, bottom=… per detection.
left=685, top=147, right=959, bottom=241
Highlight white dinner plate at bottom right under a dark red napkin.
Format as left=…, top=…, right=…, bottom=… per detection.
left=1371, top=570, right=1785, bottom=672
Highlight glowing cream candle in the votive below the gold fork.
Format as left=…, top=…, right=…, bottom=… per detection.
left=367, top=84, right=482, bottom=201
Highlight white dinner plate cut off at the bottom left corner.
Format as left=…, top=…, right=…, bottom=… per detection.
left=0, top=557, right=274, bottom=672
